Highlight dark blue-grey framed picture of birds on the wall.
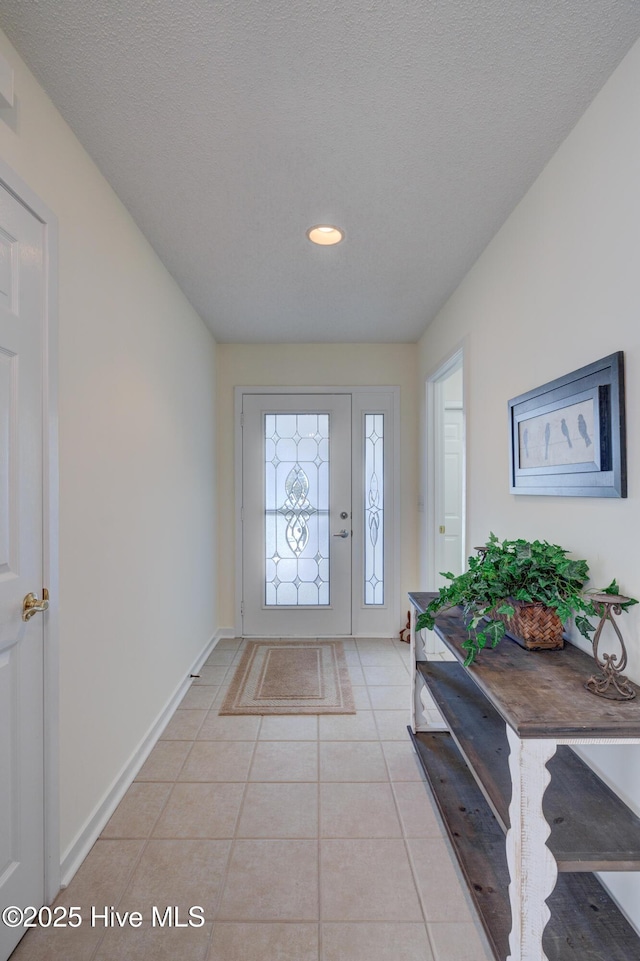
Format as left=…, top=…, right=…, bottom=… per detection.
left=509, top=350, right=627, bottom=497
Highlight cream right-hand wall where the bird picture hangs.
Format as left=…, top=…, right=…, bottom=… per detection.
left=420, top=37, right=640, bottom=929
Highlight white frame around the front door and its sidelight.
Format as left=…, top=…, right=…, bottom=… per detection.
left=234, top=384, right=402, bottom=637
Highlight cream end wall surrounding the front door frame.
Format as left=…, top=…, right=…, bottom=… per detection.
left=217, top=344, right=418, bottom=630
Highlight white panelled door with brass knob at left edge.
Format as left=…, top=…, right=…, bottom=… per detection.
left=0, top=186, right=46, bottom=961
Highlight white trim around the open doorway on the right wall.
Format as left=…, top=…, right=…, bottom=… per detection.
left=424, top=344, right=468, bottom=591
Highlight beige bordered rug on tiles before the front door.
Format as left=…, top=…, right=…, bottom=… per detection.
left=219, top=639, right=356, bottom=714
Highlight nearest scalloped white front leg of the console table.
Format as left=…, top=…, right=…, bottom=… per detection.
left=506, top=725, right=558, bottom=961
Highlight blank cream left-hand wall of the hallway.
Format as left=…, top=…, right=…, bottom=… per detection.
left=0, top=34, right=217, bottom=859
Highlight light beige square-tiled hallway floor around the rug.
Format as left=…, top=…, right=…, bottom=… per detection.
left=11, top=639, right=491, bottom=961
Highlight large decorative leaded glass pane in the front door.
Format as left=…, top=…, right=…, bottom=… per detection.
left=264, top=414, right=329, bottom=607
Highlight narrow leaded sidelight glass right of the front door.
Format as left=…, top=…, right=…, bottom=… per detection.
left=364, top=414, right=384, bottom=605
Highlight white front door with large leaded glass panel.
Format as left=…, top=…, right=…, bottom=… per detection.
left=242, top=394, right=352, bottom=637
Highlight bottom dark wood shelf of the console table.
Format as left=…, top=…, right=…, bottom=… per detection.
left=408, top=728, right=640, bottom=961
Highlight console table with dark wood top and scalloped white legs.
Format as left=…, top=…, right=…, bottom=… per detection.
left=409, top=593, right=640, bottom=961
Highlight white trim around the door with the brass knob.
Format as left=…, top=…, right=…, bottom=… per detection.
left=0, top=160, right=60, bottom=904
